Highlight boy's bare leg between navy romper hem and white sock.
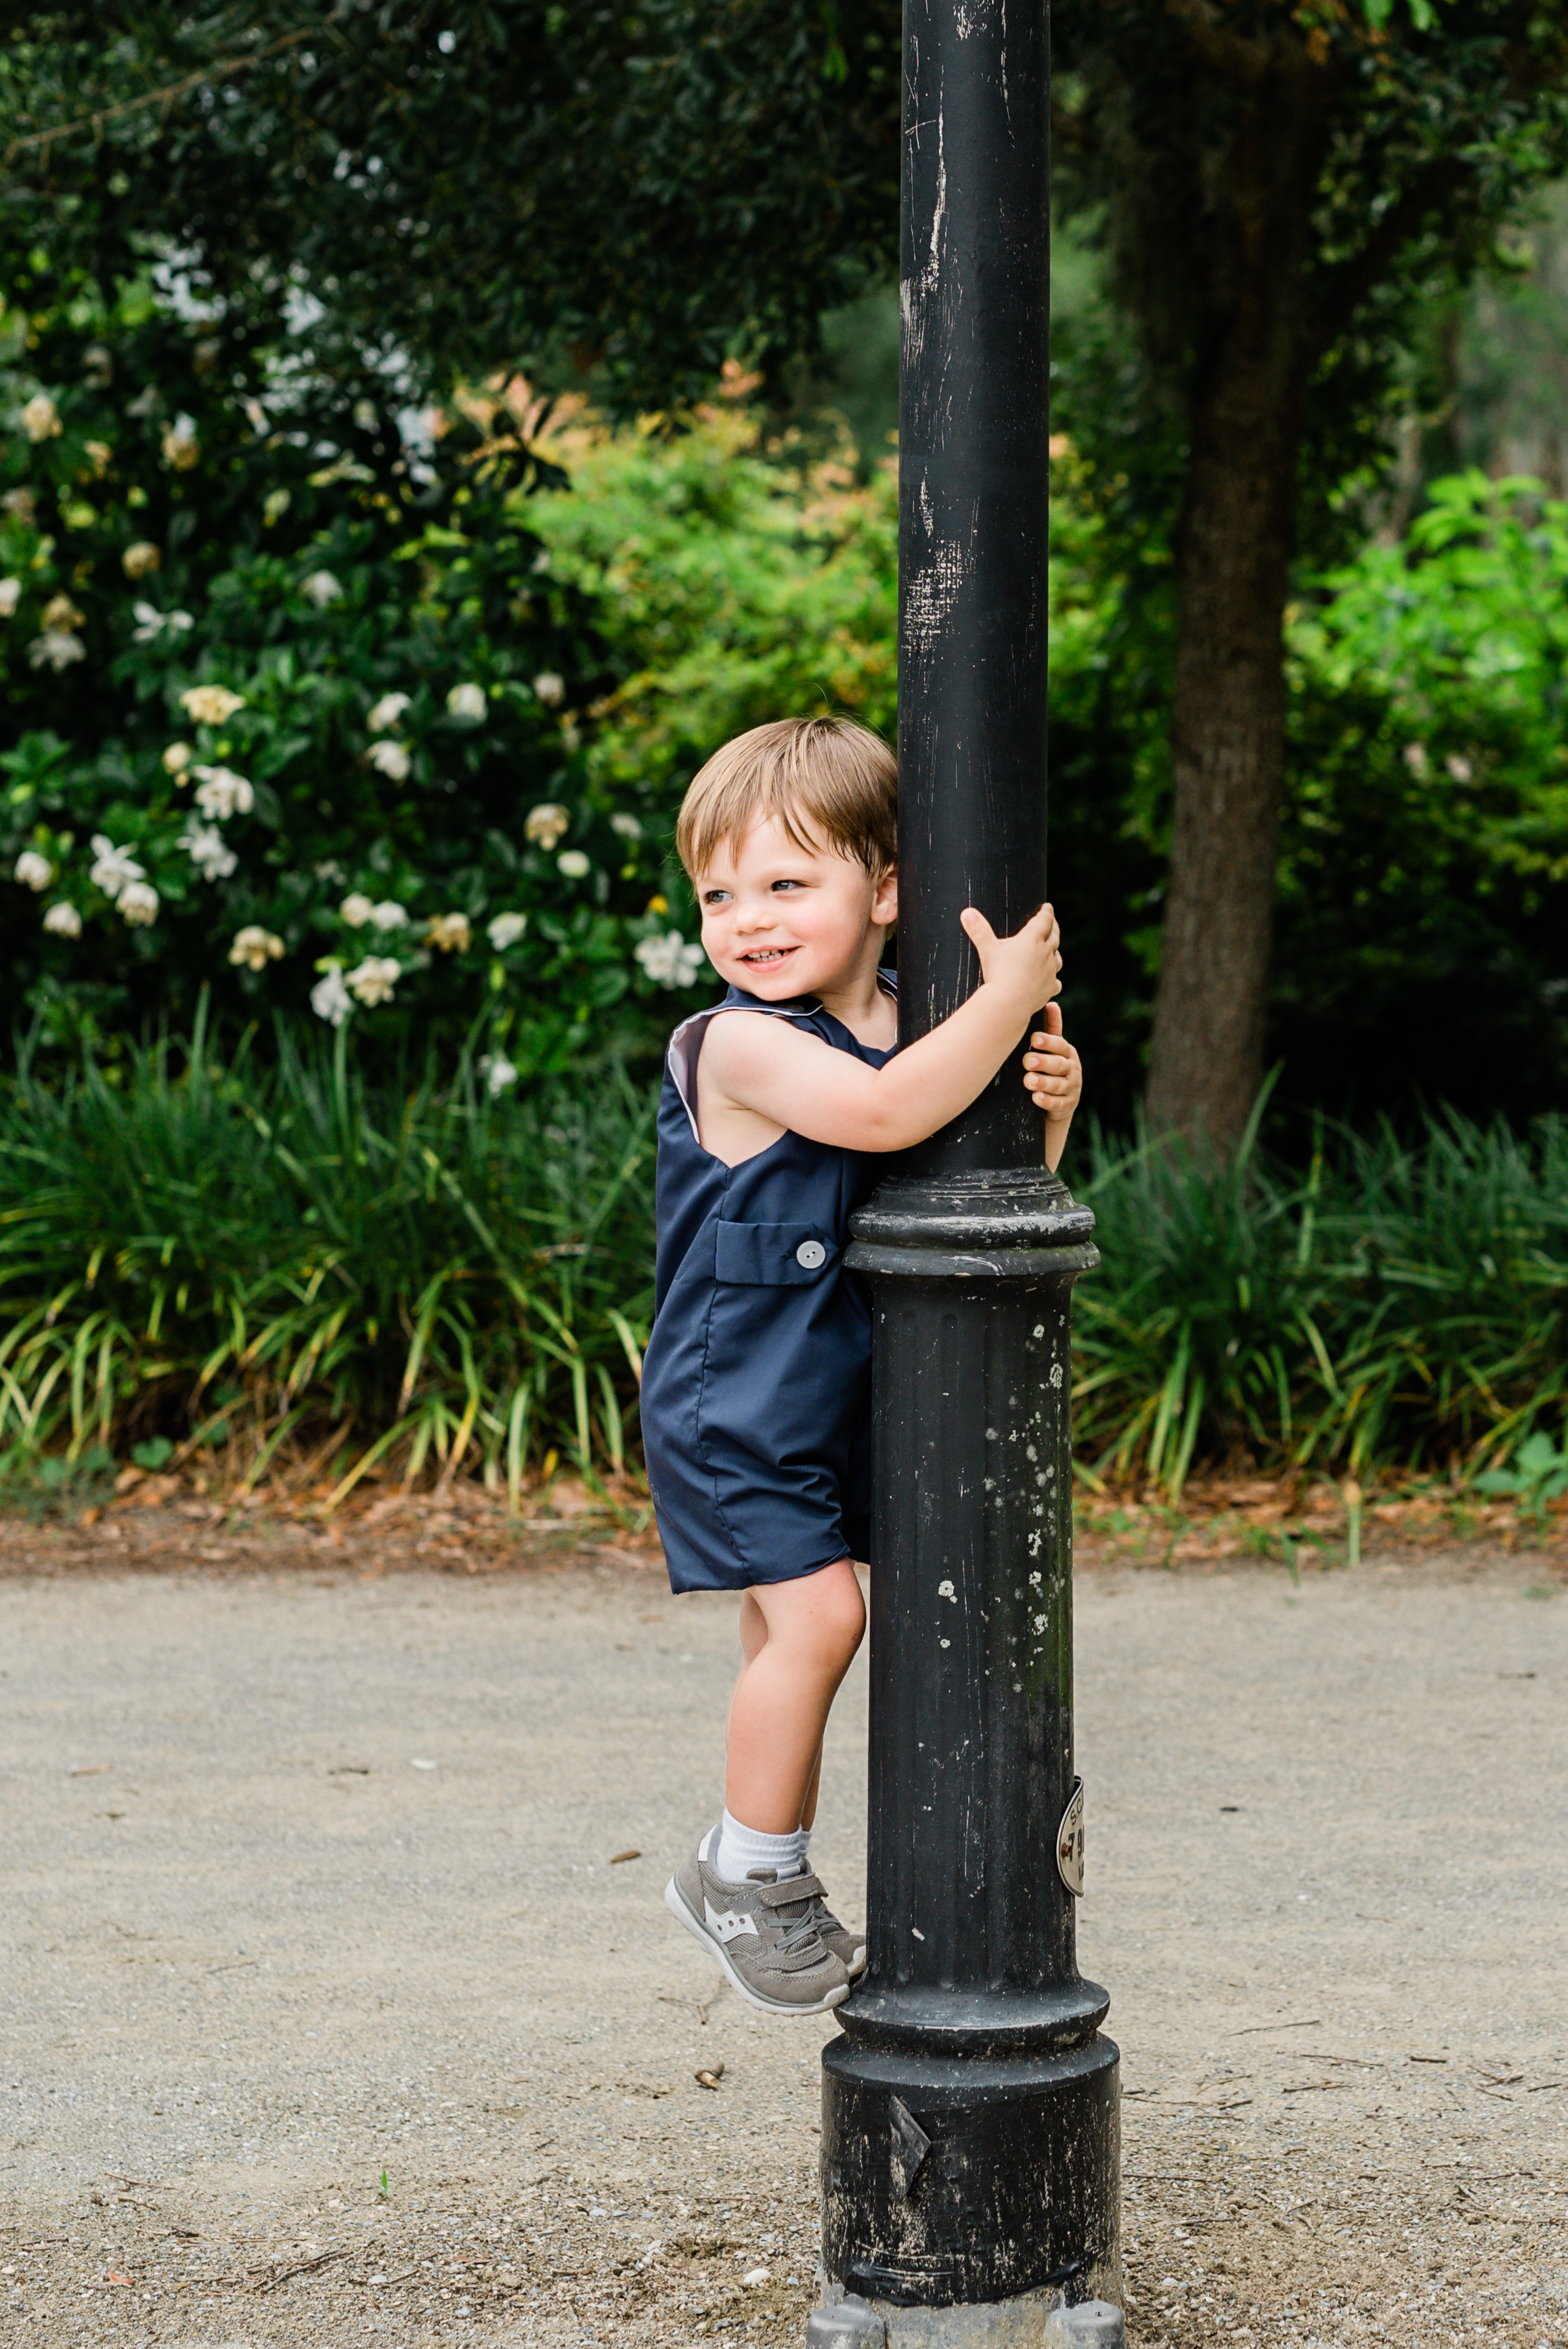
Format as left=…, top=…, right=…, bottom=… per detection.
left=725, top=1557, right=866, bottom=1834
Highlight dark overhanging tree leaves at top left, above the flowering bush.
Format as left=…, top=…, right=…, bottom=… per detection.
left=0, top=0, right=899, bottom=406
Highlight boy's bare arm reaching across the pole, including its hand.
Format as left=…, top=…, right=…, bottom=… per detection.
left=702, top=905, right=1066, bottom=1151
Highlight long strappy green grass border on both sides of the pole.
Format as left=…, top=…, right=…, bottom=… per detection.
left=0, top=1029, right=1568, bottom=1503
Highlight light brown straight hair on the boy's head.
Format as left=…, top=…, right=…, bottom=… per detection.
left=676, top=719, right=899, bottom=881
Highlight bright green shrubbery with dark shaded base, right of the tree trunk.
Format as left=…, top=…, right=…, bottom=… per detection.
left=1275, top=475, right=1568, bottom=1118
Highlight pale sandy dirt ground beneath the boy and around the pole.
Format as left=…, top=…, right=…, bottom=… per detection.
left=0, top=1492, right=1568, bottom=2349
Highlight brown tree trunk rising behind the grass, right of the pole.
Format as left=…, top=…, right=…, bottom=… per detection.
left=1146, top=47, right=1328, bottom=1148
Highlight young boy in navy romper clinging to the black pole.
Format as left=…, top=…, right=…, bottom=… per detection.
left=641, top=719, right=1082, bottom=2015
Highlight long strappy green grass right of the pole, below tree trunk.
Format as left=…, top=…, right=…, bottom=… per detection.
left=1075, top=1116, right=1568, bottom=1494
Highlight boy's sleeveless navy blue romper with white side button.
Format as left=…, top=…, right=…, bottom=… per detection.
left=643, top=972, right=894, bottom=1591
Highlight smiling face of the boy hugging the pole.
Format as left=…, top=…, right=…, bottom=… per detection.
left=697, top=815, right=899, bottom=1003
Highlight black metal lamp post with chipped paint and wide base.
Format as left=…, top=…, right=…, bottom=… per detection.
left=814, top=0, right=1120, bottom=2344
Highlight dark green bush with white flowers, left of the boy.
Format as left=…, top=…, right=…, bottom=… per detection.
left=0, top=291, right=712, bottom=1073
